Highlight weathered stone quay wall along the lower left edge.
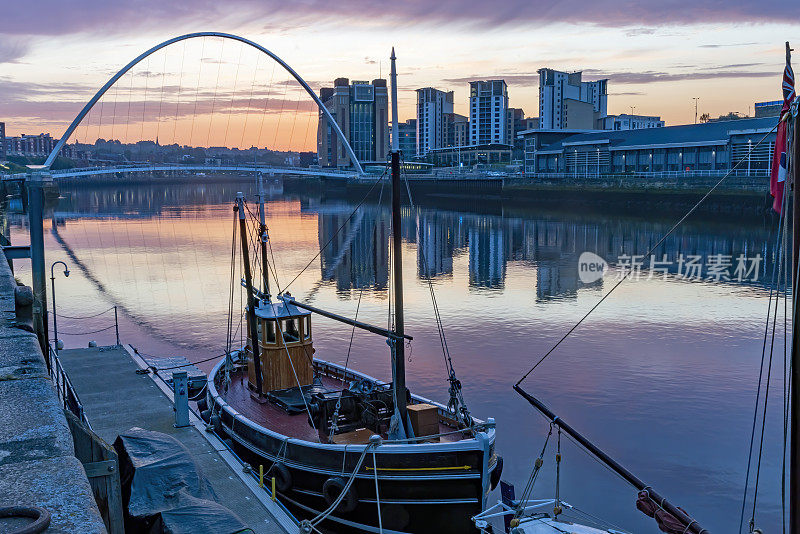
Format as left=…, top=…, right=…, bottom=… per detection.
left=0, top=252, right=106, bottom=533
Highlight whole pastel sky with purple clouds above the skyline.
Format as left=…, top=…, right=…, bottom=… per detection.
left=0, top=0, right=800, bottom=149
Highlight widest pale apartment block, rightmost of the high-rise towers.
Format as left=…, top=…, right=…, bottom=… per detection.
left=539, top=69, right=608, bottom=130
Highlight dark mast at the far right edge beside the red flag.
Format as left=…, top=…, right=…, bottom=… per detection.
left=792, top=41, right=800, bottom=534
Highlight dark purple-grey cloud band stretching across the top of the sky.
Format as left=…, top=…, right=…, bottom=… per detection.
left=3, top=0, right=800, bottom=37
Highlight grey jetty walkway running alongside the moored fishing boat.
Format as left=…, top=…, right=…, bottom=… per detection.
left=59, top=347, right=291, bottom=534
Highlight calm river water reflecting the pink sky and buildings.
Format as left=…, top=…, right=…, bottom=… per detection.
left=11, top=181, right=783, bottom=533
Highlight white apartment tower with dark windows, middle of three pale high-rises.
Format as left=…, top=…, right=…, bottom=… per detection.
left=469, top=80, right=510, bottom=146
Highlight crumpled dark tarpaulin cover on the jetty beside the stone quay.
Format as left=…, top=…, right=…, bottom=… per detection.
left=114, top=429, right=246, bottom=534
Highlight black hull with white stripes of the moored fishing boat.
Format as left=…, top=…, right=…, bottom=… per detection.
left=206, top=362, right=501, bottom=533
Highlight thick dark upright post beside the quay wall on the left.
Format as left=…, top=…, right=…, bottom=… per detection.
left=27, top=174, right=50, bottom=360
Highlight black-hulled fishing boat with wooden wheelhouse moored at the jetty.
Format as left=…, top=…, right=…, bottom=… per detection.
left=200, top=50, right=502, bottom=533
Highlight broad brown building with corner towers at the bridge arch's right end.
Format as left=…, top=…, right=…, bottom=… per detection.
left=317, top=78, right=389, bottom=167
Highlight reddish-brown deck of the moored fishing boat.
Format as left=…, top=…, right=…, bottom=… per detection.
left=220, top=369, right=463, bottom=443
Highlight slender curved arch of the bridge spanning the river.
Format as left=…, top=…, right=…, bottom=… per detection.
left=44, top=32, right=364, bottom=174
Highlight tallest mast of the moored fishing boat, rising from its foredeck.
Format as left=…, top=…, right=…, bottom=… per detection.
left=390, top=47, right=408, bottom=435
